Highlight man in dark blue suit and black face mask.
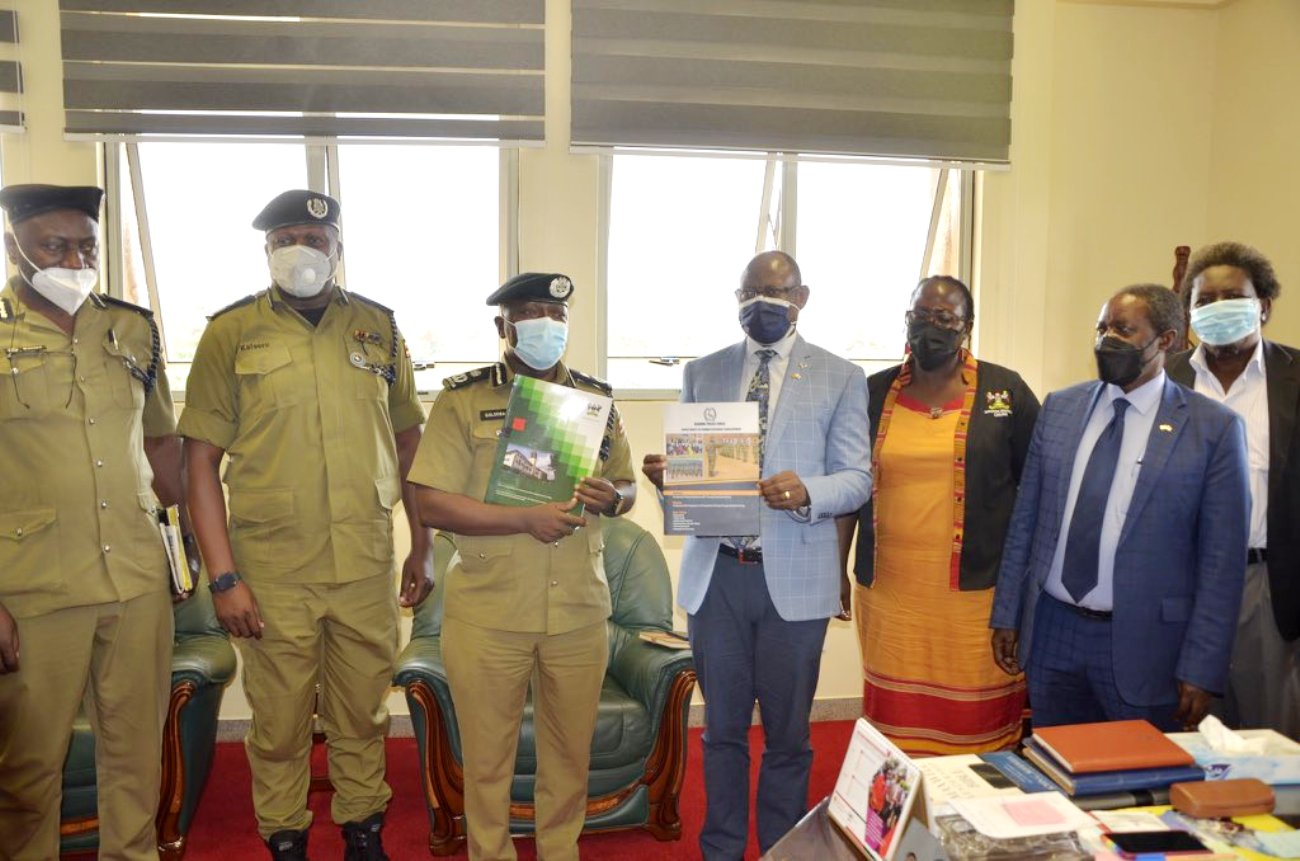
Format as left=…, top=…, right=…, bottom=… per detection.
left=989, top=285, right=1251, bottom=730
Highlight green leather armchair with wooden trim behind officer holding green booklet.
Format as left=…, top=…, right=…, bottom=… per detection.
left=394, top=518, right=696, bottom=856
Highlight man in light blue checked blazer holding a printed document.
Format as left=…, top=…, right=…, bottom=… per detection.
left=642, top=251, right=871, bottom=861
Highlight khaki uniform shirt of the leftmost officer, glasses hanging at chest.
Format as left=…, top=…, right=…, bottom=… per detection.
left=0, top=281, right=176, bottom=618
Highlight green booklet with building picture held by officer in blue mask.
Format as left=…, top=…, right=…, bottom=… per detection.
left=484, top=375, right=614, bottom=514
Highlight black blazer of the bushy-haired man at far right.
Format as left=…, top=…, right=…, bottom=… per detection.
left=1165, top=339, right=1300, bottom=640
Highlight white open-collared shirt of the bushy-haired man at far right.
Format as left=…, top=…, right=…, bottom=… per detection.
left=1191, top=338, right=1269, bottom=549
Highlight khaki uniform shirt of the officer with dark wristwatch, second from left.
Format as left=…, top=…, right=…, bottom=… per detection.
left=181, top=287, right=424, bottom=583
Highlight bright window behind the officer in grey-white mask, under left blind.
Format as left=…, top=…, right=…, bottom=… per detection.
left=108, top=142, right=501, bottom=390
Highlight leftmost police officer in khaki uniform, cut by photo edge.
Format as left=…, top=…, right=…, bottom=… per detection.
left=0, top=185, right=181, bottom=860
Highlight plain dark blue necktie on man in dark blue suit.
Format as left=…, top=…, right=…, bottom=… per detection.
left=1061, top=398, right=1128, bottom=603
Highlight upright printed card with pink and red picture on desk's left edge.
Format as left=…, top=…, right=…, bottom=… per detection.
left=827, top=718, right=920, bottom=861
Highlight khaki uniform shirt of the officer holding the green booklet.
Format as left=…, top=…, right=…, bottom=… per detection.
left=410, top=363, right=633, bottom=633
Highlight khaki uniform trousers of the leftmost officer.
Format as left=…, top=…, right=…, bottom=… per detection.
left=0, top=589, right=173, bottom=861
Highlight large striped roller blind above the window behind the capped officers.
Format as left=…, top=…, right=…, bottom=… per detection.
left=59, top=0, right=545, bottom=142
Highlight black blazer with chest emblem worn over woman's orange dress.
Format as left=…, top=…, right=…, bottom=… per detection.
left=853, top=362, right=1039, bottom=592
